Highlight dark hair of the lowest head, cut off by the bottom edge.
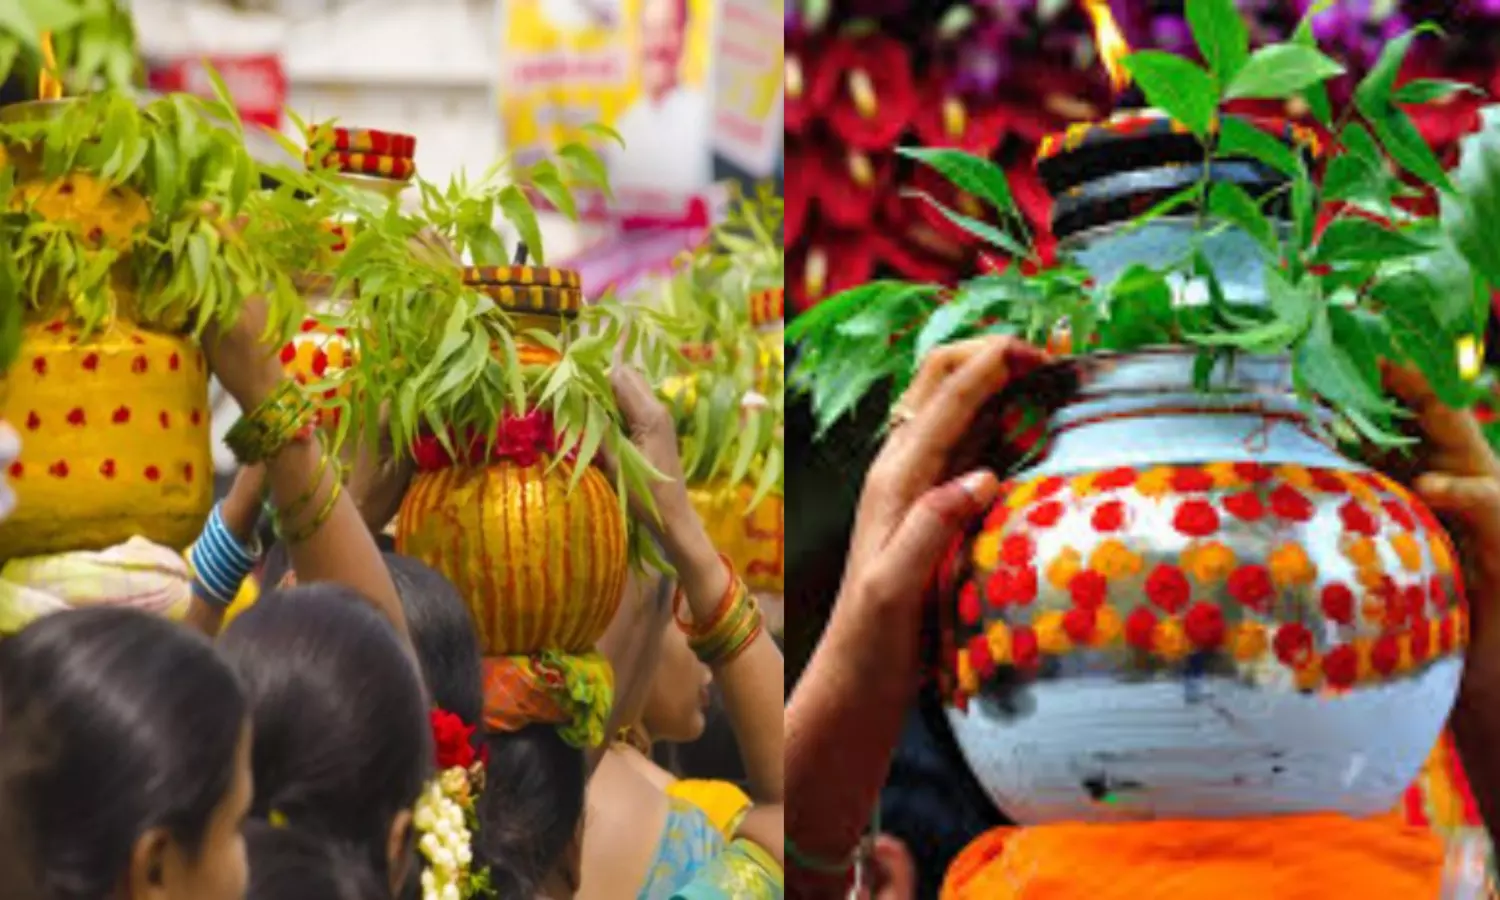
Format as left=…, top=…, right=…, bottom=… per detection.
left=245, top=822, right=390, bottom=900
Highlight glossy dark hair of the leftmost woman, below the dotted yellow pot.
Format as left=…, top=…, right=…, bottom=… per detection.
left=0, top=608, right=246, bottom=900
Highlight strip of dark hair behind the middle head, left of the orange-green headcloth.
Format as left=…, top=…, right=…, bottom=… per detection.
left=386, top=554, right=485, bottom=726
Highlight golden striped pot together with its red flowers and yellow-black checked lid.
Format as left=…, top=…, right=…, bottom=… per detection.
left=396, top=266, right=627, bottom=656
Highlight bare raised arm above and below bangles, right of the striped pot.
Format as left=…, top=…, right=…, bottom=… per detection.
left=668, top=515, right=786, bottom=803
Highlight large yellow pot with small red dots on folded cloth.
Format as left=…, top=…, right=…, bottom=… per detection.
left=0, top=320, right=213, bottom=560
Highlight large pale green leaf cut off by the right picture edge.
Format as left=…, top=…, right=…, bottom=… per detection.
left=1443, top=107, right=1500, bottom=287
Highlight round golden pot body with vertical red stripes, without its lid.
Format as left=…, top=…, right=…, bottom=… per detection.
left=396, top=459, right=627, bottom=656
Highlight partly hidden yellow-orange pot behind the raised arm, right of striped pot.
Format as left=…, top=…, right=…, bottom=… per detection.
left=687, top=480, right=786, bottom=594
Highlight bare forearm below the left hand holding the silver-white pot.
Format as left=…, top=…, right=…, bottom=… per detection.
left=786, top=594, right=920, bottom=897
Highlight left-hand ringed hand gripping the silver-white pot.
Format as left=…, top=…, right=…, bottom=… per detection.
left=836, top=338, right=1047, bottom=639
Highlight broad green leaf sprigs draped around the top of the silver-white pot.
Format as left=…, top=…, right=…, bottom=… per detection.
left=789, top=0, right=1500, bottom=446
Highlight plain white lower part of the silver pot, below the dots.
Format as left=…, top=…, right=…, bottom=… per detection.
left=948, top=659, right=1463, bottom=825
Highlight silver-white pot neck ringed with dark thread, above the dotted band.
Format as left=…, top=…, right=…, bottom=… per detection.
left=1034, top=348, right=1347, bottom=474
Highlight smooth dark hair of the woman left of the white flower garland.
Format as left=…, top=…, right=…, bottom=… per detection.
left=221, top=584, right=432, bottom=884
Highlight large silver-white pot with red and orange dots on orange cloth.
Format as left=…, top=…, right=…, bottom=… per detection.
left=945, top=350, right=1469, bottom=824
